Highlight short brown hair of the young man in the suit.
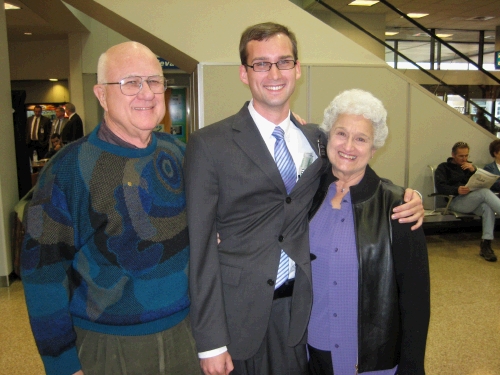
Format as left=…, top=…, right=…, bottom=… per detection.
left=240, top=22, right=299, bottom=65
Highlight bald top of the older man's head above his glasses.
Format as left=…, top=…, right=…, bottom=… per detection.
left=97, top=42, right=162, bottom=83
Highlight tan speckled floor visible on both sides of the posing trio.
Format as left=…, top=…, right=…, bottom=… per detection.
left=0, top=233, right=500, bottom=375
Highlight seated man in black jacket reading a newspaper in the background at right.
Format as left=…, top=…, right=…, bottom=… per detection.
left=435, top=142, right=500, bottom=262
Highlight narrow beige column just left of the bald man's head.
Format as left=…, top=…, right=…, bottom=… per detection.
left=68, top=33, right=87, bottom=134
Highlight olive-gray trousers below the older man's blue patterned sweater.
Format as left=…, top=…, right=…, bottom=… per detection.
left=75, top=318, right=201, bottom=375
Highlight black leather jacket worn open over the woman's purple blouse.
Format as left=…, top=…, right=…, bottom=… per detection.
left=310, top=166, right=430, bottom=375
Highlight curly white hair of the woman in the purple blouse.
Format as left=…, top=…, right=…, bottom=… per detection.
left=320, top=89, right=389, bottom=149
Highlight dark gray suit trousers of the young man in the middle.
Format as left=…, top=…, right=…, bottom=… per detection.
left=231, top=297, right=308, bottom=375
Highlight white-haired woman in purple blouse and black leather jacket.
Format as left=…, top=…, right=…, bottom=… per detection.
left=308, top=90, right=430, bottom=375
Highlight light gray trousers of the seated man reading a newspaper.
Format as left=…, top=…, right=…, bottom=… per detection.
left=450, top=189, right=500, bottom=240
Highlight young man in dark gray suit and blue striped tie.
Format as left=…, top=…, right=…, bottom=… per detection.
left=185, top=23, right=423, bottom=375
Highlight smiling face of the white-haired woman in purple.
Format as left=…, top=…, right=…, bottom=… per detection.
left=327, top=114, right=375, bottom=182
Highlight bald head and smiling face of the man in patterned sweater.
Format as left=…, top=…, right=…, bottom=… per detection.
left=94, top=42, right=165, bottom=144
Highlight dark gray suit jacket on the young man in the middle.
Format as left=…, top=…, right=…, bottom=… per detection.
left=185, top=103, right=328, bottom=360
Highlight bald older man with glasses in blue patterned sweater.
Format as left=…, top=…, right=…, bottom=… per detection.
left=22, top=42, right=200, bottom=375
